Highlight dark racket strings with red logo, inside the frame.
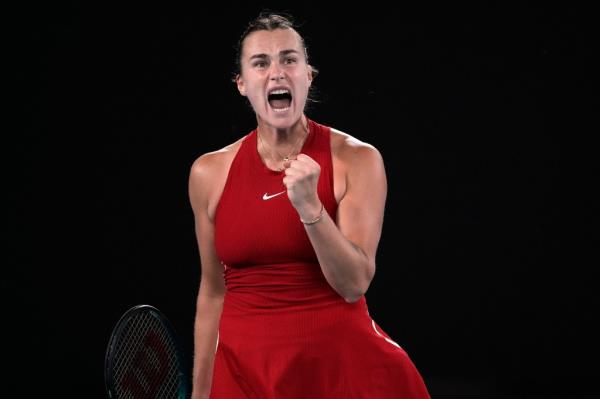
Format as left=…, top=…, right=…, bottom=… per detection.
left=114, top=312, right=183, bottom=399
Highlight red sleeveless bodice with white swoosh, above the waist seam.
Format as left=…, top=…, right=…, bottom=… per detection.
left=215, top=122, right=337, bottom=268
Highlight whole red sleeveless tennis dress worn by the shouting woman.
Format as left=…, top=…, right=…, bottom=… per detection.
left=211, top=120, right=429, bottom=399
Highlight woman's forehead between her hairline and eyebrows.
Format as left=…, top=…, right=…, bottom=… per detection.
left=242, top=29, right=304, bottom=58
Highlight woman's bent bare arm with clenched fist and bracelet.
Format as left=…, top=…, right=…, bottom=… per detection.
left=284, top=138, right=387, bottom=303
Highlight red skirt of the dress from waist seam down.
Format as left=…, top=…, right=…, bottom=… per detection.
left=210, top=263, right=429, bottom=399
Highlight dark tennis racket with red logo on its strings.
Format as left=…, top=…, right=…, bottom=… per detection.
left=104, top=305, right=190, bottom=399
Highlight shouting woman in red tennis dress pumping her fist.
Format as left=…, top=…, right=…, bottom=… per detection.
left=189, top=10, right=429, bottom=399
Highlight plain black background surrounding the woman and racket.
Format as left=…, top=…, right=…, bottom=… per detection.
left=7, top=2, right=600, bottom=399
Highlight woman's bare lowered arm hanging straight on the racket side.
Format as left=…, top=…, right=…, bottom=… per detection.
left=189, top=156, right=225, bottom=399
